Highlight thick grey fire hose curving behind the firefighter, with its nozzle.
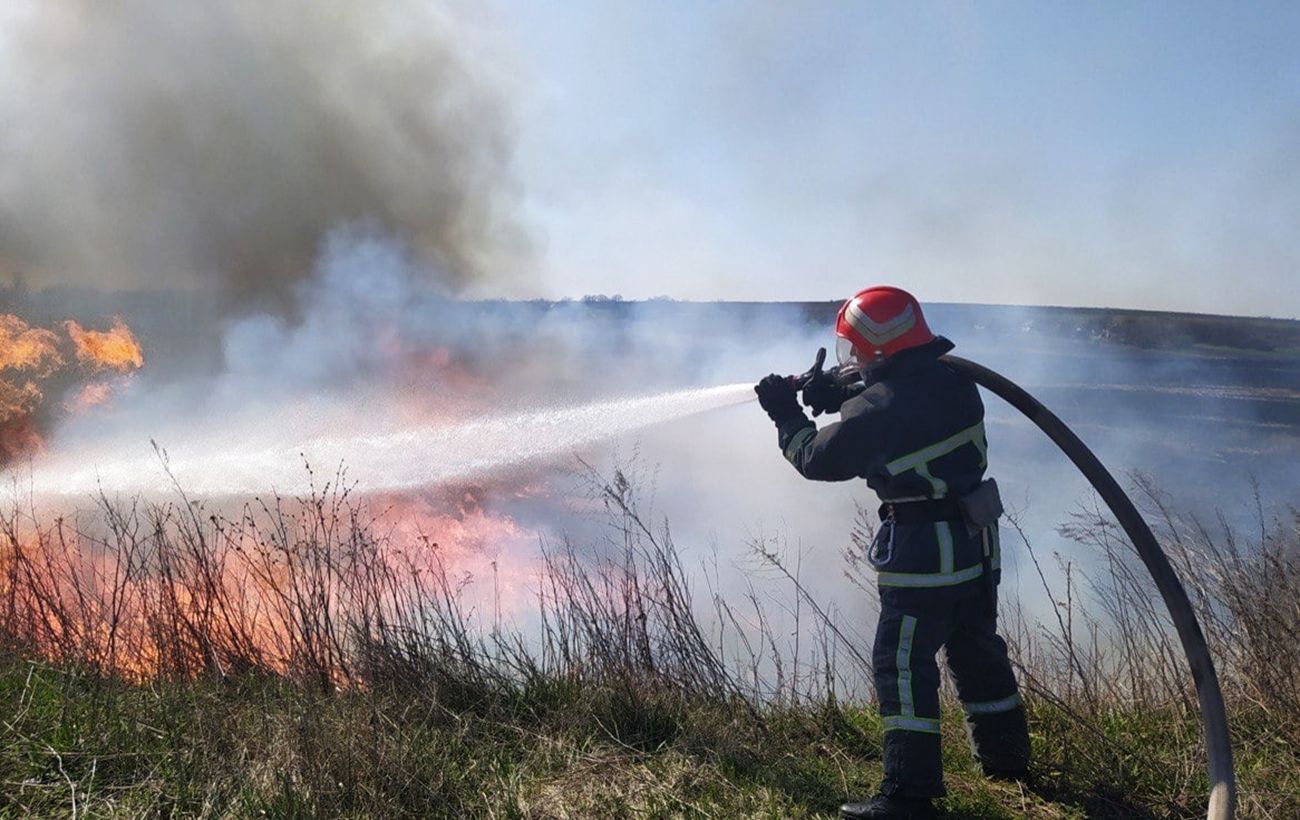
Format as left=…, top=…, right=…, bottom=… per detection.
left=793, top=348, right=1236, bottom=820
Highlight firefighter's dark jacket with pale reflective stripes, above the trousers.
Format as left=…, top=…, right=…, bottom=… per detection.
left=777, top=337, right=1000, bottom=591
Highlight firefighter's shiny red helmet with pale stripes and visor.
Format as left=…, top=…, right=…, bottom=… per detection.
left=835, top=286, right=935, bottom=365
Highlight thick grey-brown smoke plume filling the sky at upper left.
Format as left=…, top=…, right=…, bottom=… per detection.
left=0, top=0, right=524, bottom=304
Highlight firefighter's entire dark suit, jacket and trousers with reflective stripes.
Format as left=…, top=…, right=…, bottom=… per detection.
left=777, top=338, right=1030, bottom=798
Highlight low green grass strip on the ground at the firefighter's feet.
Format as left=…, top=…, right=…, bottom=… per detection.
left=0, top=656, right=1300, bottom=819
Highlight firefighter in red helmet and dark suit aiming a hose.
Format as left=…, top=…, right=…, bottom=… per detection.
left=754, top=287, right=1030, bottom=819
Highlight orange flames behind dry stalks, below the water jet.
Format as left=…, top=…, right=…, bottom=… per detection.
left=0, top=487, right=540, bottom=686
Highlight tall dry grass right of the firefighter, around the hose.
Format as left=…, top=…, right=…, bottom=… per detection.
left=1004, top=476, right=1300, bottom=817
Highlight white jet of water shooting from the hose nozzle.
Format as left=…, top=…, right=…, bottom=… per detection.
left=20, top=383, right=754, bottom=498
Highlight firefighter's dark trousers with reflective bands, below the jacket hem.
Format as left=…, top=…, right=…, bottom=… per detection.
left=872, top=585, right=1030, bottom=797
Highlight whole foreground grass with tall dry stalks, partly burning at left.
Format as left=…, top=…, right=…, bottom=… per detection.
left=0, top=473, right=1300, bottom=817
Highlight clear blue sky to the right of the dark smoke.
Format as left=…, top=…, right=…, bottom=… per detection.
left=495, top=0, right=1300, bottom=317
